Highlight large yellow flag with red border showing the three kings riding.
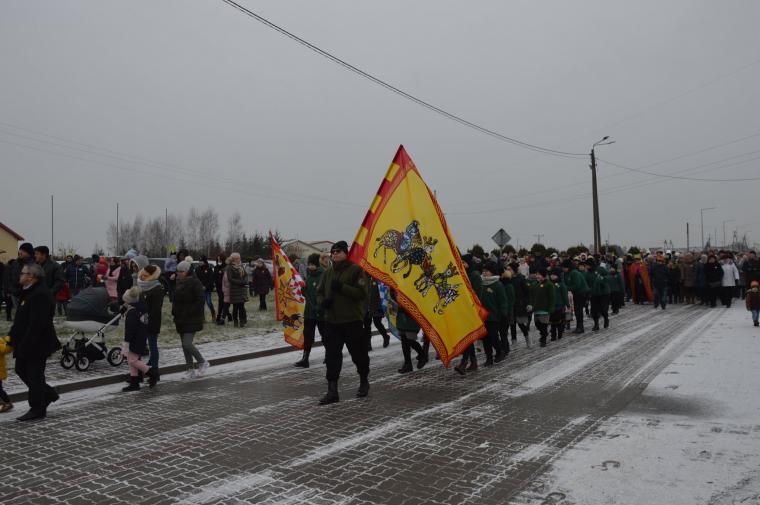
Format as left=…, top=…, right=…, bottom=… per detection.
left=349, top=146, right=488, bottom=366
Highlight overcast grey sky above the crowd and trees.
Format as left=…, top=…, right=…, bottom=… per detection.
left=0, top=0, right=760, bottom=254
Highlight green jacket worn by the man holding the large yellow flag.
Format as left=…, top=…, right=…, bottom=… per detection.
left=317, top=260, right=367, bottom=324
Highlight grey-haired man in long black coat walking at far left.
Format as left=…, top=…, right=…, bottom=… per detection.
left=9, top=264, right=61, bottom=421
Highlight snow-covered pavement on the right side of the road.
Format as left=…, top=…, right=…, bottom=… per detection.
left=517, top=304, right=760, bottom=505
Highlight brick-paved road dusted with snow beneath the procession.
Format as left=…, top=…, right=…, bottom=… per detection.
left=0, top=306, right=723, bottom=505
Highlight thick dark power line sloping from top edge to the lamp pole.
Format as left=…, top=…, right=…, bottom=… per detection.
left=217, top=0, right=587, bottom=158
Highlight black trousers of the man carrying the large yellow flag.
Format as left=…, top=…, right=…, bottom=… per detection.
left=322, top=321, right=369, bottom=381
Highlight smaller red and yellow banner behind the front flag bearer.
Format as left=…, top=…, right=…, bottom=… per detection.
left=269, top=233, right=306, bottom=349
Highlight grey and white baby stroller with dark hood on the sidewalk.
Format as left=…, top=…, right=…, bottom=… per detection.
left=61, top=288, right=124, bottom=372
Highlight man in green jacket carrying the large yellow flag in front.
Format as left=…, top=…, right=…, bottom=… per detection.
left=317, top=240, right=369, bottom=405
